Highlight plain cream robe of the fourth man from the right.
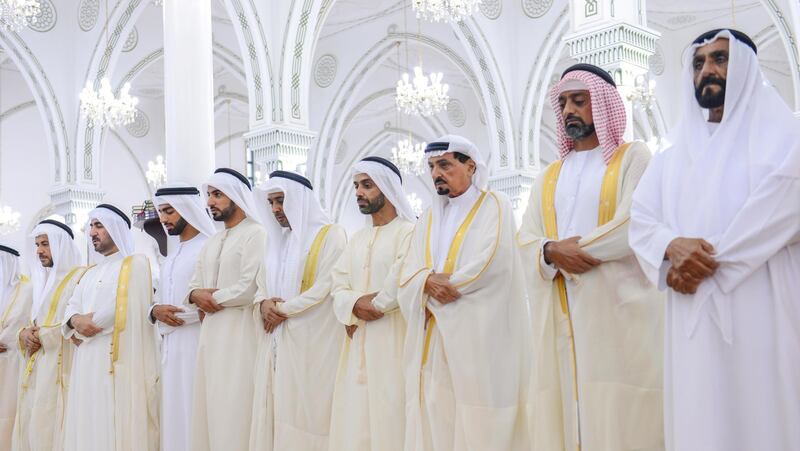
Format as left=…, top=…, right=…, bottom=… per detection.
left=330, top=217, right=414, bottom=451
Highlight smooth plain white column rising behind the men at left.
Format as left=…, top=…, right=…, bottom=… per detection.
left=163, top=0, right=214, bottom=185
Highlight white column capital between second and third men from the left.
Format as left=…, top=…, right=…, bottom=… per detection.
left=50, top=185, right=105, bottom=264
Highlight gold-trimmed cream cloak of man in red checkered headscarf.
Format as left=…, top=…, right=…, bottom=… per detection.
left=518, top=143, right=664, bottom=451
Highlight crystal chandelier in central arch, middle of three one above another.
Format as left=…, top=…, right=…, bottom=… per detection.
left=395, top=66, right=450, bottom=116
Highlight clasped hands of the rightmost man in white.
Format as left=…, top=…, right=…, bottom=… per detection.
left=665, top=238, right=719, bottom=294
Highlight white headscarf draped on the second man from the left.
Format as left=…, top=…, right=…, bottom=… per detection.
left=28, top=219, right=81, bottom=321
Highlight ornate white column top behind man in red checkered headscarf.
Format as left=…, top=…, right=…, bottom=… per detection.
left=564, top=0, right=660, bottom=140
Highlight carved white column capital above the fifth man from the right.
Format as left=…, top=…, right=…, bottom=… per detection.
left=244, top=124, right=317, bottom=178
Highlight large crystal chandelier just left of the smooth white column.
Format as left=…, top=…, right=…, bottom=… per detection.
left=80, top=77, right=139, bottom=127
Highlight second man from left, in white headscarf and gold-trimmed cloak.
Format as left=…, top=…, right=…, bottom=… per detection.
left=12, top=219, right=86, bottom=451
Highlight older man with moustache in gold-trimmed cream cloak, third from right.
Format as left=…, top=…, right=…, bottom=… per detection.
left=398, top=135, right=530, bottom=451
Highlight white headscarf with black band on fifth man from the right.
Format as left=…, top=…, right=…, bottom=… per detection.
left=255, top=171, right=331, bottom=300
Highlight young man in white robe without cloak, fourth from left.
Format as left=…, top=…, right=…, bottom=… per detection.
left=150, top=183, right=217, bottom=451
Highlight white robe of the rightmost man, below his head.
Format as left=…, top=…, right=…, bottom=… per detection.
left=630, top=139, right=800, bottom=451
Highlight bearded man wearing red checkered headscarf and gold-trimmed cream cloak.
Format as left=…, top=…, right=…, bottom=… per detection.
left=518, top=64, right=664, bottom=451
